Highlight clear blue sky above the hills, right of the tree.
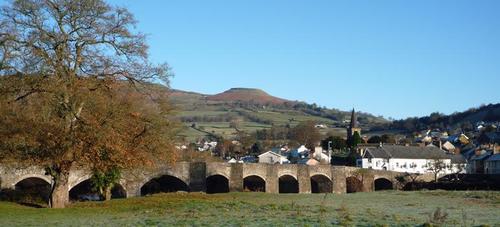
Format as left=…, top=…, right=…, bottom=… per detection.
left=4, top=0, right=500, bottom=118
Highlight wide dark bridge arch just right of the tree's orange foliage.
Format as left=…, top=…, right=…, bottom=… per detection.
left=141, top=174, right=190, bottom=196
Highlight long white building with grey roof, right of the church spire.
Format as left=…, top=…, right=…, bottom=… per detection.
left=357, top=145, right=465, bottom=175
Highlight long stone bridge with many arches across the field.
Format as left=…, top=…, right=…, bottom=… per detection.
left=0, top=162, right=432, bottom=205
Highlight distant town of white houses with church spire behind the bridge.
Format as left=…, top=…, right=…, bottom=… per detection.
left=177, top=107, right=500, bottom=176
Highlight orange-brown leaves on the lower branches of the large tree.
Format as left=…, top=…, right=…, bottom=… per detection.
left=0, top=76, right=176, bottom=168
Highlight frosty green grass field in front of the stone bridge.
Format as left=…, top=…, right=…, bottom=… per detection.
left=0, top=191, right=500, bottom=226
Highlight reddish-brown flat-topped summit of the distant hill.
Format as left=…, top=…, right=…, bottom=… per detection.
left=207, top=88, right=293, bottom=104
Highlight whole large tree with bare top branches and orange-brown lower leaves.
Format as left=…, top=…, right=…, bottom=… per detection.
left=0, top=0, right=174, bottom=207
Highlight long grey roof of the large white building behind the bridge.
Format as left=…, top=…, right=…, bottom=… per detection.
left=366, top=146, right=450, bottom=159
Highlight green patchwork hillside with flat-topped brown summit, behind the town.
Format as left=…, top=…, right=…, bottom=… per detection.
left=170, top=88, right=388, bottom=141
